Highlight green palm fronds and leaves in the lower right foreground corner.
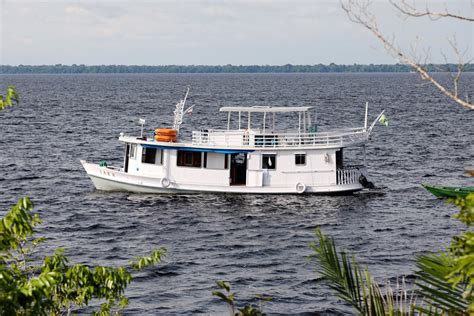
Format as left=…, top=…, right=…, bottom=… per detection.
left=310, top=194, right=474, bottom=315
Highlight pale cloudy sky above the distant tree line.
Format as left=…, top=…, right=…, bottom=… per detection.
left=0, top=0, right=474, bottom=65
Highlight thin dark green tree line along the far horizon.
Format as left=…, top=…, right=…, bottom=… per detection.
left=0, top=63, right=474, bottom=74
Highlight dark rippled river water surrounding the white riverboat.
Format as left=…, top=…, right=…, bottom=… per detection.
left=0, top=74, right=474, bottom=314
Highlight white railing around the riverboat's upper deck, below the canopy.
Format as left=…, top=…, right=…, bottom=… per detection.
left=192, top=128, right=368, bottom=148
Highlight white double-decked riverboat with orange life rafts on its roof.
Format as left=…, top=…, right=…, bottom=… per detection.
left=81, top=89, right=383, bottom=194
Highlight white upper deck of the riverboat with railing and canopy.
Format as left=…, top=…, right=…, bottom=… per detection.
left=120, top=106, right=370, bottom=150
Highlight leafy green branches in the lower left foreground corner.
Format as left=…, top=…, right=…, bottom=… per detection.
left=0, top=197, right=166, bottom=315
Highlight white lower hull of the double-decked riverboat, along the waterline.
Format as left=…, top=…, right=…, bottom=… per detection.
left=81, top=160, right=363, bottom=194
